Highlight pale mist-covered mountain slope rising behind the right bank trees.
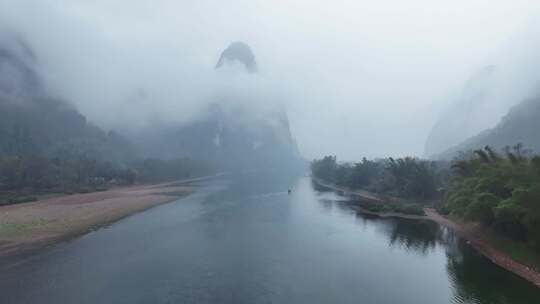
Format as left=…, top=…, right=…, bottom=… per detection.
left=424, top=54, right=540, bottom=159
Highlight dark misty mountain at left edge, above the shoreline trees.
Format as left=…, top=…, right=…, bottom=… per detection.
left=0, top=33, right=133, bottom=160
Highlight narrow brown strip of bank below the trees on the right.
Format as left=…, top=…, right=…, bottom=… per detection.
left=313, top=178, right=540, bottom=287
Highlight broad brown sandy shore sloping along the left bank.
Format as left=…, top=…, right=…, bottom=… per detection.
left=0, top=181, right=193, bottom=258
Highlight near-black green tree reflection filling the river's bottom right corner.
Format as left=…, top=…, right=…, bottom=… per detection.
left=446, top=238, right=540, bottom=304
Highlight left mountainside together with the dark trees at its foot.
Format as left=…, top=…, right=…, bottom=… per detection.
left=0, top=34, right=214, bottom=204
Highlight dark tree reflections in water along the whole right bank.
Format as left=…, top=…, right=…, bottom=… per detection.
left=314, top=183, right=540, bottom=304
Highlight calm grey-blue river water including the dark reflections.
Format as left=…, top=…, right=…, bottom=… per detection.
left=0, top=174, right=540, bottom=304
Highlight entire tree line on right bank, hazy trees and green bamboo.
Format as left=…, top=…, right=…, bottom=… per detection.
left=311, top=144, right=540, bottom=251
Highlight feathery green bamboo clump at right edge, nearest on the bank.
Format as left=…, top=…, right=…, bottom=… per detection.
left=440, top=144, right=540, bottom=251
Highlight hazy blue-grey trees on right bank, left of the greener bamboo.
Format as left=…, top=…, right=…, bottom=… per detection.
left=311, top=156, right=448, bottom=202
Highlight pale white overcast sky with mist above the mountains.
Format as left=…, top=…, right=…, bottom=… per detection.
left=0, top=0, right=540, bottom=160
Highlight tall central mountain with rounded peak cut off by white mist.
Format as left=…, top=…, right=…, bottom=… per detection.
left=208, top=42, right=300, bottom=166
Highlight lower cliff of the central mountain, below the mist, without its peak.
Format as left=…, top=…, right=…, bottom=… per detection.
left=173, top=103, right=299, bottom=168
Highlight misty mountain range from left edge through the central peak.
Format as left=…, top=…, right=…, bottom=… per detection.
left=0, top=35, right=300, bottom=170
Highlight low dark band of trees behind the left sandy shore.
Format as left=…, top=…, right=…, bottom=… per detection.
left=0, top=155, right=214, bottom=205
